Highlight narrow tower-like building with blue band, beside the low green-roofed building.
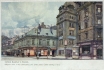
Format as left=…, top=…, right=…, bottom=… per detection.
left=57, top=2, right=78, bottom=57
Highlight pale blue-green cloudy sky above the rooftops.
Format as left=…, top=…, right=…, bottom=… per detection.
left=1, top=2, right=65, bottom=37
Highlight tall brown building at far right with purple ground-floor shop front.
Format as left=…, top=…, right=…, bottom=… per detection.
left=77, top=2, right=103, bottom=59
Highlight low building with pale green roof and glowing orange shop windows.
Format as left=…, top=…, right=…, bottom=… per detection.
left=7, top=25, right=57, bottom=57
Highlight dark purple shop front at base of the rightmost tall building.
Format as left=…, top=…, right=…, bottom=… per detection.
left=78, top=40, right=103, bottom=59
